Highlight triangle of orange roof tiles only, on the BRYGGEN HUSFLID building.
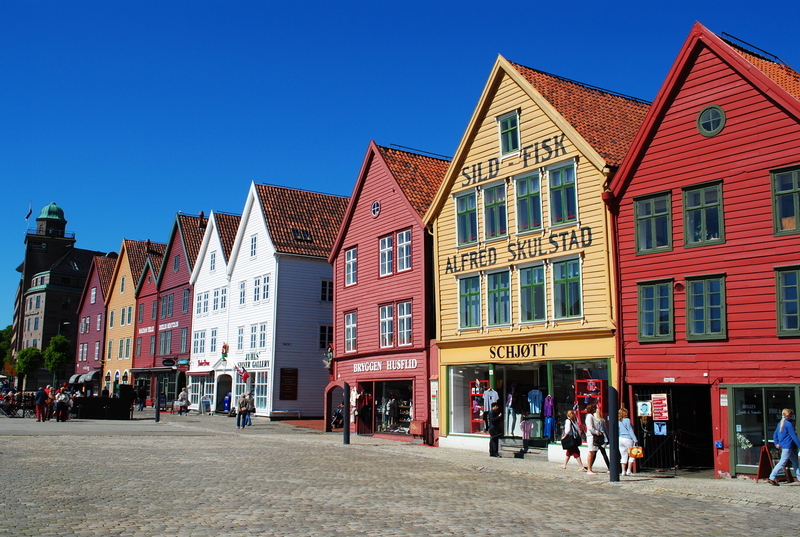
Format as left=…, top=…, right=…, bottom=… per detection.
left=378, top=146, right=450, bottom=217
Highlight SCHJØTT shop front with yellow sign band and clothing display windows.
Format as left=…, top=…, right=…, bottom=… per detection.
left=440, top=337, right=614, bottom=450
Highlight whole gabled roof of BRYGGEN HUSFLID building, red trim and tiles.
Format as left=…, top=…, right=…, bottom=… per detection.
left=328, top=140, right=450, bottom=263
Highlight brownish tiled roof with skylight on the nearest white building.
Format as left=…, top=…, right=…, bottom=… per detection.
left=255, top=185, right=348, bottom=259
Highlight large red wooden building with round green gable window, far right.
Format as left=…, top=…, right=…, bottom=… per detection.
left=604, top=23, right=800, bottom=475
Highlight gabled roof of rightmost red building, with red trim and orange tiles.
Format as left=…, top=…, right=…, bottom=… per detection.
left=609, top=22, right=800, bottom=199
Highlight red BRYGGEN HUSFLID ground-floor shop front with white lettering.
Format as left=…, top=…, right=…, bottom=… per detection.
left=326, top=353, right=434, bottom=443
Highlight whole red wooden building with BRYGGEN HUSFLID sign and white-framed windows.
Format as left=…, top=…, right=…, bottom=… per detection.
left=326, top=142, right=449, bottom=443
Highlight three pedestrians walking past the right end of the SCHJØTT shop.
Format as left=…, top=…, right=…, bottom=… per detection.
left=562, top=403, right=639, bottom=475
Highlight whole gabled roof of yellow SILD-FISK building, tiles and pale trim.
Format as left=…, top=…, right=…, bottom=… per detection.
left=423, top=55, right=650, bottom=225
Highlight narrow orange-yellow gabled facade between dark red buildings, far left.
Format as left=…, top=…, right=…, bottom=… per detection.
left=102, top=241, right=137, bottom=394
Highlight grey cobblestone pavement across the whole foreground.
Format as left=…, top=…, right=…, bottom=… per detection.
left=0, top=413, right=800, bottom=537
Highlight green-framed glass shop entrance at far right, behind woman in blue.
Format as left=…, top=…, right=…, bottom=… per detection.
left=728, top=386, right=798, bottom=473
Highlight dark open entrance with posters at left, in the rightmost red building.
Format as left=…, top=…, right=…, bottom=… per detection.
left=631, top=386, right=714, bottom=470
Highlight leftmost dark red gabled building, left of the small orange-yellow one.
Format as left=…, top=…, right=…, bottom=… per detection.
left=75, top=252, right=117, bottom=396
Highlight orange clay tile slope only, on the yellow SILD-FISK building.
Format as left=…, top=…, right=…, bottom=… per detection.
left=509, top=62, right=650, bottom=166
